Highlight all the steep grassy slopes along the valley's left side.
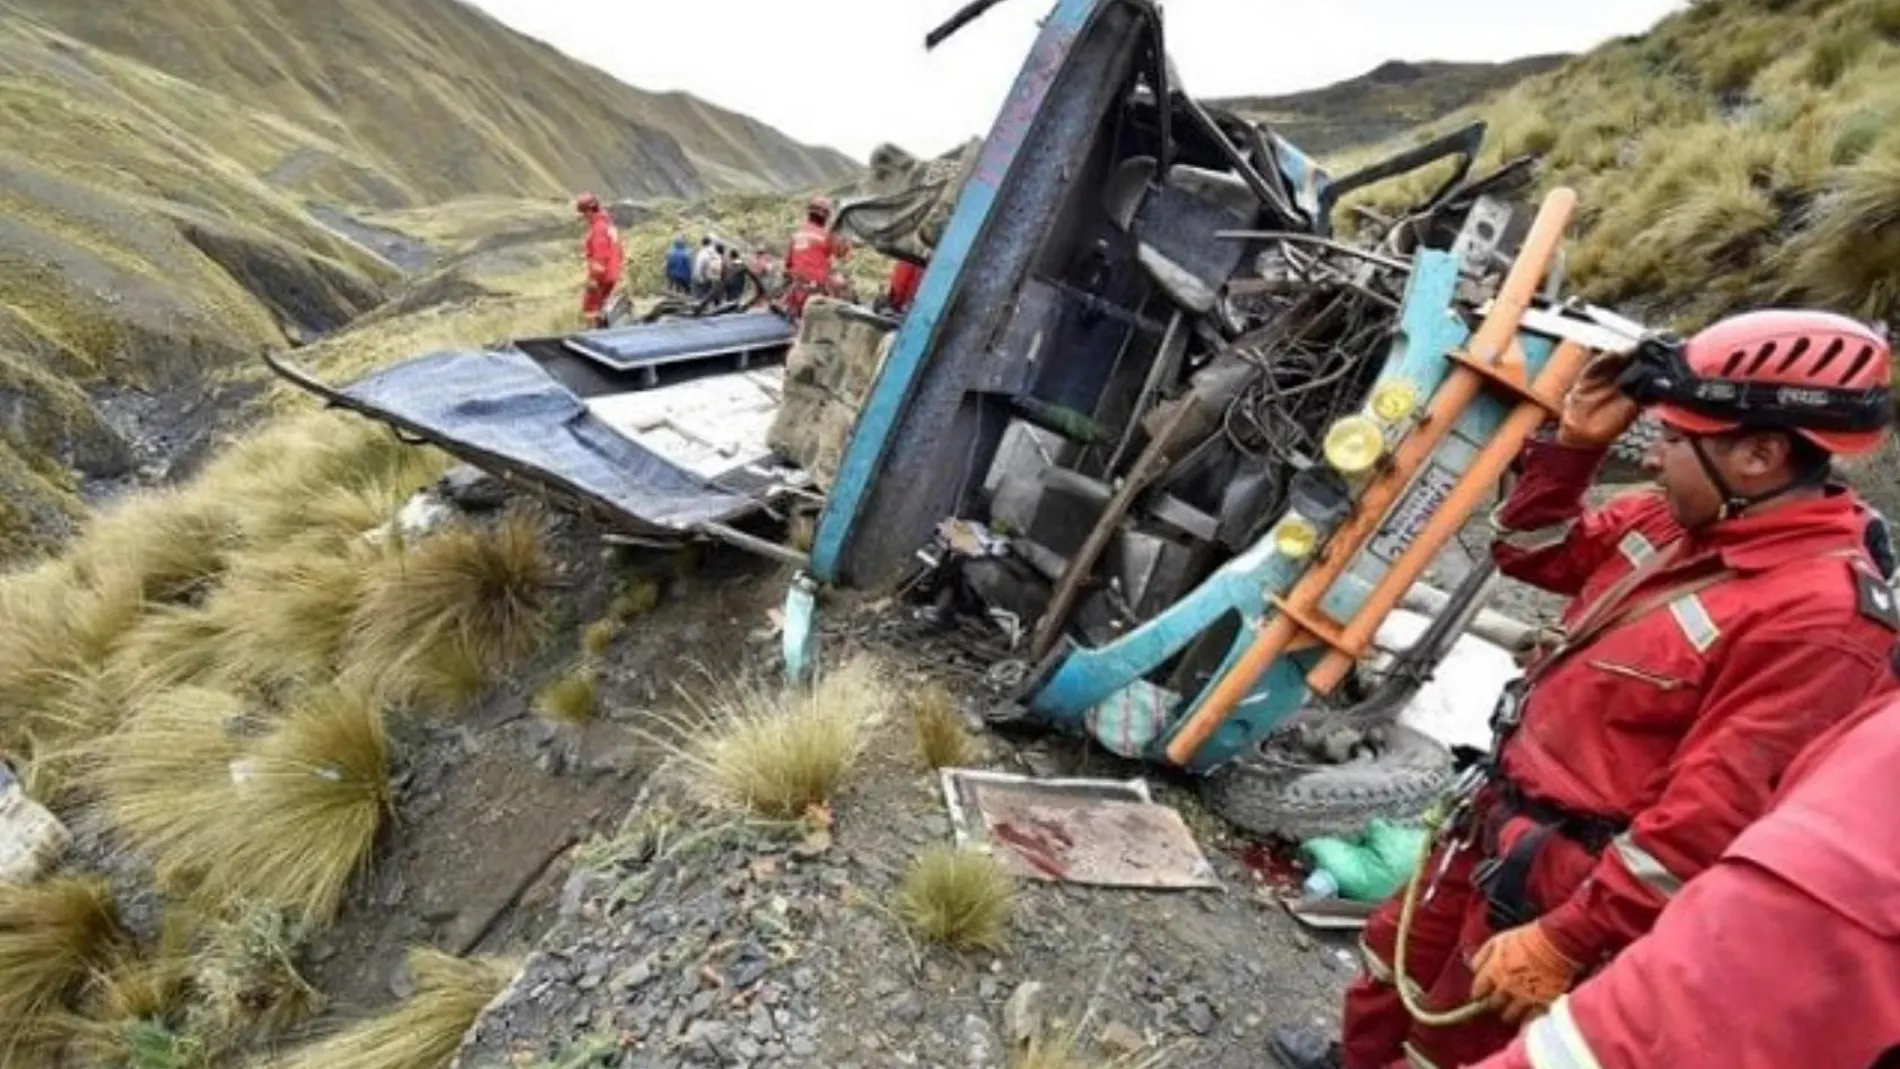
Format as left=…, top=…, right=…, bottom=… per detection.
left=0, top=0, right=853, bottom=558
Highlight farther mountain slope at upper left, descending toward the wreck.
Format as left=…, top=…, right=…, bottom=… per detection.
left=13, top=0, right=855, bottom=207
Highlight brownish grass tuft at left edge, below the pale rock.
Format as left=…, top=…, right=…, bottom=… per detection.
left=0, top=877, right=125, bottom=1069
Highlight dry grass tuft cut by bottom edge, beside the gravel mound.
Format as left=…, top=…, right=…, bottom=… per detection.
left=266, top=947, right=513, bottom=1069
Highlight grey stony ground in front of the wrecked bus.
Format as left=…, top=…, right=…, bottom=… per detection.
left=460, top=584, right=1355, bottom=1069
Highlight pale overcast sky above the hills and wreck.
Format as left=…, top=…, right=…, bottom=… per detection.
left=467, top=0, right=1682, bottom=159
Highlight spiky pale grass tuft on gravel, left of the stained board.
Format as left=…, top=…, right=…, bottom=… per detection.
left=659, top=655, right=891, bottom=820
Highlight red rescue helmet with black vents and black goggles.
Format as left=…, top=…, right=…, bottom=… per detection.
left=1630, top=309, right=1892, bottom=456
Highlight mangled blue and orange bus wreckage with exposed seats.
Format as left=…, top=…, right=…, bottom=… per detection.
left=260, top=0, right=1642, bottom=835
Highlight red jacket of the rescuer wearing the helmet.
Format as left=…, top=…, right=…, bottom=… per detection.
left=1493, top=441, right=1896, bottom=965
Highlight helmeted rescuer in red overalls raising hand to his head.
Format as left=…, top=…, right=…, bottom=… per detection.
left=1273, top=311, right=1900, bottom=1069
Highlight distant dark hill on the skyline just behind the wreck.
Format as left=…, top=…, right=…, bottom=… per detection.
left=1218, top=55, right=1568, bottom=156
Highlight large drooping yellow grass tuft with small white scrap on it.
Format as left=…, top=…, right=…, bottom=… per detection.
left=93, top=687, right=390, bottom=921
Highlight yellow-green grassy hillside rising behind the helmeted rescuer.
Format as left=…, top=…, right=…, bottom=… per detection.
left=1337, top=0, right=1900, bottom=327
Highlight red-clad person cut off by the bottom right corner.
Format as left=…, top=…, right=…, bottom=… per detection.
left=1478, top=697, right=1900, bottom=1069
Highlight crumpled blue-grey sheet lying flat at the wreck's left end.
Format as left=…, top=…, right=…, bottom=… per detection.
left=336, top=349, right=754, bottom=532
